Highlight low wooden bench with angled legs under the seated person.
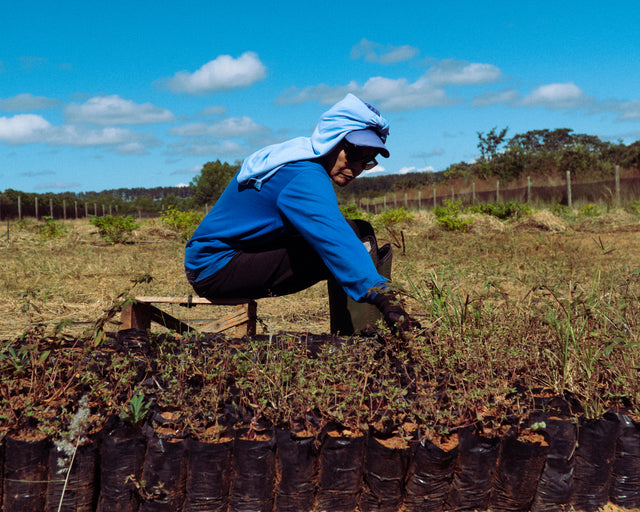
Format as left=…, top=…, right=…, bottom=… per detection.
left=120, top=296, right=257, bottom=338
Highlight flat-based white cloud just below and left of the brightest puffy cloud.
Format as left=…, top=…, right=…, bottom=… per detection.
left=65, top=94, right=174, bottom=126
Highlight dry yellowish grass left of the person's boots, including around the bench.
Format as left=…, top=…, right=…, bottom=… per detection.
left=0, top=220, right=336, bottom=339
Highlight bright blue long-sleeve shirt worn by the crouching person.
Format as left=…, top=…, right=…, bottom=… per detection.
left=185, top=160, right=386, bottom=300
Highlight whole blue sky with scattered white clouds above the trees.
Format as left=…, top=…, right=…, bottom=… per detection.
left=0, top=0, right=640, bottom=193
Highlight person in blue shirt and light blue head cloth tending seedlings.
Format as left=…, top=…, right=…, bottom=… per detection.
left=185, top=94, right=413, bottom=335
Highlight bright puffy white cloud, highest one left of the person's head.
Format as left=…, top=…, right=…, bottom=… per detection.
left=166, top=52, right=267, bottom=94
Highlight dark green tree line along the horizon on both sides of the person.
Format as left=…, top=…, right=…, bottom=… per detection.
left=0, top=127, right=640, bottom=218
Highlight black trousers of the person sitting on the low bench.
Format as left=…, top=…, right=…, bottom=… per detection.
left=191, top=219, right=375, bottom=299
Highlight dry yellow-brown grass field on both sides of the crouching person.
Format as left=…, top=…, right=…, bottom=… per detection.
left=0, top=211, right=640, bottom=339
